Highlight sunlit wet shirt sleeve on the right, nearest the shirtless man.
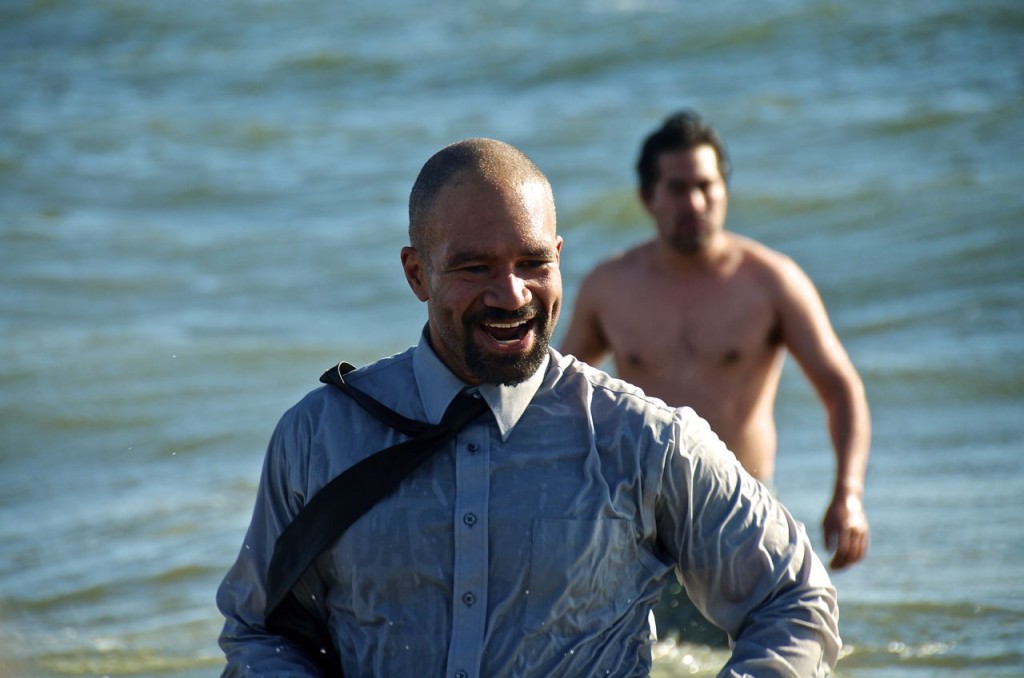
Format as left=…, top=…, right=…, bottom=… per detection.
left=657, top=410, right=842, bottom=678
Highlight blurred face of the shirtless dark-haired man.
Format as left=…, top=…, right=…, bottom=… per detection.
left=642, top=145, right=729, bottom=254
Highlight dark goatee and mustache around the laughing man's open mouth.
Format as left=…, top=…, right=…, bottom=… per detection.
left=463, top=307, right=551, bottom=386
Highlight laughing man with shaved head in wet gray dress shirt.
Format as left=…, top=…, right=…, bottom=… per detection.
left=217, top=139, right=840, bottom=678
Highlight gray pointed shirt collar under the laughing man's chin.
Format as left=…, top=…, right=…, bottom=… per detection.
left=413, top=330, right=551, bottom=440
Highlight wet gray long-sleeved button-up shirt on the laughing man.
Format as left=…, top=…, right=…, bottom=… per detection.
left=217, top=340, right=840, bottom=678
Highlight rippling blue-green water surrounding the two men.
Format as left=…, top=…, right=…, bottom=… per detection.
left=0, top=0, right=1024, bottom=678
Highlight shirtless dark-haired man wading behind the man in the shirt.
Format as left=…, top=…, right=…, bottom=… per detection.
left=561, top=112, right=870, bottom=569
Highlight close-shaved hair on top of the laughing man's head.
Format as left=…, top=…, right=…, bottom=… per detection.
left=409, top=138, right=550, bottom=250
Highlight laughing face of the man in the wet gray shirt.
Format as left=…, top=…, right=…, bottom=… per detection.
left=402, top=176, right=562, bottom=384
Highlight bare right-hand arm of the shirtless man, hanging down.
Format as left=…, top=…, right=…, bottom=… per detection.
left=779, top=259, right=871, bottom=569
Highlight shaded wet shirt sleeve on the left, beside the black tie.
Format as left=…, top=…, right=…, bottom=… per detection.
left=217, top=410, right=329, bottom=677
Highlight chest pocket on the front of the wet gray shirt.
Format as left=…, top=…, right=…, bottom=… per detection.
left=523, top=518, right=643, bottom=636
